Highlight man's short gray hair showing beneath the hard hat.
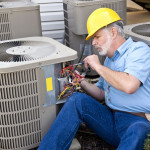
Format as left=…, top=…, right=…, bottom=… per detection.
left=105, top=21, right=125, bottom=38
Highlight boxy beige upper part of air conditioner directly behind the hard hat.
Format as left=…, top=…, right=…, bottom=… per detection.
left=63, top=0, right=126, bottom=35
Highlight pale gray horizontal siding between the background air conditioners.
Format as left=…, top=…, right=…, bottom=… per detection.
left=31, top=0, right=64, bottom=42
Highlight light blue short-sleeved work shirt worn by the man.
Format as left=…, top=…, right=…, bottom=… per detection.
left=96, top=38, right=150, bottom=113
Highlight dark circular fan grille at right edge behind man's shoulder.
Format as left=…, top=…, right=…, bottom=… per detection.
left=132, top=24, right=150, bottom=37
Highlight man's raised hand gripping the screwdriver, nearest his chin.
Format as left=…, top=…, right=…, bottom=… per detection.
left=83, top=55, right=101, bottom=71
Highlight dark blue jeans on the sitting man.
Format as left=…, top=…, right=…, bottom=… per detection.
left=38, top=93, right=150, bottom=150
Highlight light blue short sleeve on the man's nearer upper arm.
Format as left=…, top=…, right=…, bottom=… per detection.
left=124, top=42, right=150, bottom=84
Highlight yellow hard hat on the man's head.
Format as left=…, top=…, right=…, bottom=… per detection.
left=86, top=8, right=122, bottom=40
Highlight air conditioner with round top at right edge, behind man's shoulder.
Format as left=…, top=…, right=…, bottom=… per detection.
left=124, top=22, right=150, bottom=46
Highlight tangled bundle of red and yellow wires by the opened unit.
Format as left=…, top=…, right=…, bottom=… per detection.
left=58, top=65, right=82, bottom=100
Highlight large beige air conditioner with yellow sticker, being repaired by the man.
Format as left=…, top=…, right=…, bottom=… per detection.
left=0, top=37, right=77, bottom=150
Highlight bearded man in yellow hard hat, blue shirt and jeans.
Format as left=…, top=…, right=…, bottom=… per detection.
left=39, top=8, right=150, bottom=150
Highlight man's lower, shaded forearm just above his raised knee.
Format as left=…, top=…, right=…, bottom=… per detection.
left=80, top=80, right=105, bottom=102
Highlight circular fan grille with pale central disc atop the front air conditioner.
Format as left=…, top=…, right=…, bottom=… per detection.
left=0, top=41, right=55, bottom=62
